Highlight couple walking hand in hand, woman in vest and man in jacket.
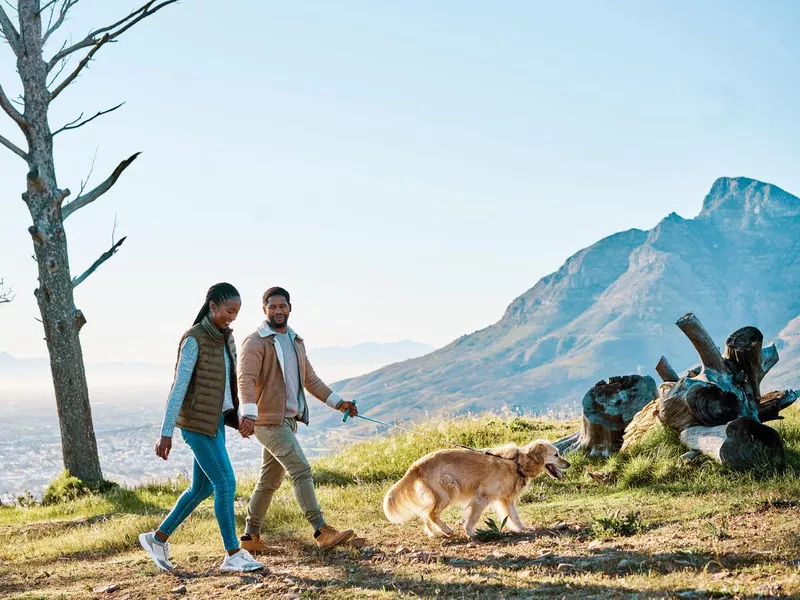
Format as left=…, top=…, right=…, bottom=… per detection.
left=139, top=283, right=358, bottom=572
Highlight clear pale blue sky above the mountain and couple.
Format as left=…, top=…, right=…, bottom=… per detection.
left=0, top=0, right=800, bottom=362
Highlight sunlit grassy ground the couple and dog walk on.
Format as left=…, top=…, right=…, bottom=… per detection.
left=0, top=408, right=800, bottom=600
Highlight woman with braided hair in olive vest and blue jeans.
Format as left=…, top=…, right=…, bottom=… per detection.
left=139, top=283, right=264, bottom=571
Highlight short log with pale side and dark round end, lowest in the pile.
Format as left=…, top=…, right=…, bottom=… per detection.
left=681, top=417, right=784, bottom=469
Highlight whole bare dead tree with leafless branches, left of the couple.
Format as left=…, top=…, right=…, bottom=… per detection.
left=0, top=0, right=177, bottom=481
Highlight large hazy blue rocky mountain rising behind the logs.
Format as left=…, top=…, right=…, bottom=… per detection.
left=337, top=178, right=800, bottom=418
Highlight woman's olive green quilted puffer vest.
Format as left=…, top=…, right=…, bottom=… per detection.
left=176, top=319, right=239, bottom=437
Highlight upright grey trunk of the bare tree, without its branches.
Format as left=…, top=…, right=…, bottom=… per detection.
left=17, top=0, right=103, bottom=481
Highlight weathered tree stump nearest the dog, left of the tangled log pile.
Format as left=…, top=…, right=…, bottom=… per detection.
left=555, top=375, right=658, bottom=456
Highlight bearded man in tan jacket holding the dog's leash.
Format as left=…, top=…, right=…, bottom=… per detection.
left=239, top=287, right=358, bottom=552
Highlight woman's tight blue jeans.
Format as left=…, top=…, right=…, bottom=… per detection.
left=158, top=417, right=239, bottom=550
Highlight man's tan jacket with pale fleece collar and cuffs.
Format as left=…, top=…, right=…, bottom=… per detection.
left=238, top=322, right=342, bottom=425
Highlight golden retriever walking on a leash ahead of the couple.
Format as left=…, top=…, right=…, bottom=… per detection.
left=383, top=440, right=569, bottom=538
